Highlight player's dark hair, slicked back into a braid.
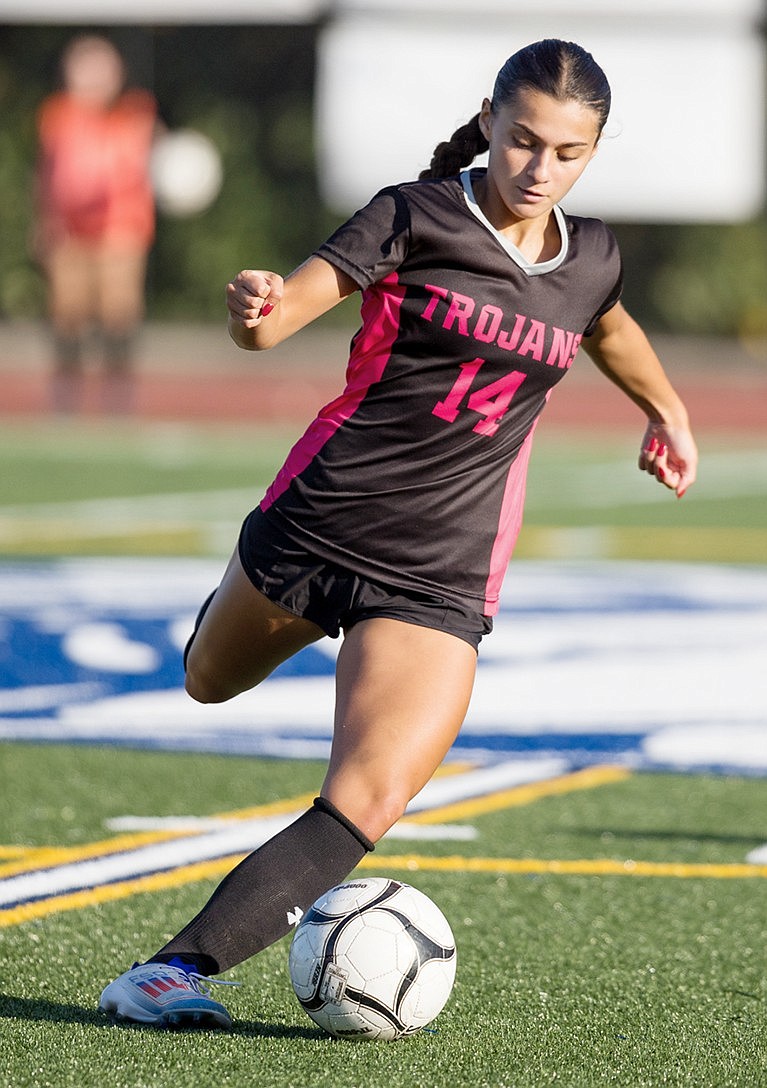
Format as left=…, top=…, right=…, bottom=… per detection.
left=419, top=38, right=610, bottom=177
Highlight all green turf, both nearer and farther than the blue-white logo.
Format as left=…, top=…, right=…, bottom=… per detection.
left=0, top=420, right=767, bottom=1088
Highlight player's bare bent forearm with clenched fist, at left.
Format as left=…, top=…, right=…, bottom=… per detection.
left=226, top=257, right=358, bottom=351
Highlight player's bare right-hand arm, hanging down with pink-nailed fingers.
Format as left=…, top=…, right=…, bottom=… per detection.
left=583, top=304, right=697, bottom=498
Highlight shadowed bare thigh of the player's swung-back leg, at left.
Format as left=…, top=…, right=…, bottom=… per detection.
left=186, top=552, right=324, bottom=703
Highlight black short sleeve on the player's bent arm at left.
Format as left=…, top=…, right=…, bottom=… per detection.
left=316, top=187, right=410, bottom=289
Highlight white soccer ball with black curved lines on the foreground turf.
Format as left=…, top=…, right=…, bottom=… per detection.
left=288, top=877, right=456, bottom=1039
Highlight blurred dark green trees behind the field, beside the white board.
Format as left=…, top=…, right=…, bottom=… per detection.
left=0, top=25, right=767, bottom=337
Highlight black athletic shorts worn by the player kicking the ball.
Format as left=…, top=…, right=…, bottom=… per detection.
left=239, top=507, right=493, bottom=650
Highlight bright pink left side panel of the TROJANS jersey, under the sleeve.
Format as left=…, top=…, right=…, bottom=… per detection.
left=261, top=272, right=405, bottom=510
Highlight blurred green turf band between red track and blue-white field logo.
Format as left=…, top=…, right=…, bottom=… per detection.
left=0, top=420, right=767, bottom=562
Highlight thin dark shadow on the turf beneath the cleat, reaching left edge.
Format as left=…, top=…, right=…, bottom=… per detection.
left=0, top=993, right=327, bottom=1041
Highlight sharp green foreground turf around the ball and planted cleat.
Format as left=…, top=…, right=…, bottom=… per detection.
left=0, top=744, right=767, bottom=1088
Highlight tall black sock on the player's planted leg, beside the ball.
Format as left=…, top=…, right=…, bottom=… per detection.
left=151, top=798, right=374, bottom=975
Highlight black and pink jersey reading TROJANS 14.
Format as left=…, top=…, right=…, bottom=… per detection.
left=261, top=171, right=621, bottom=616
